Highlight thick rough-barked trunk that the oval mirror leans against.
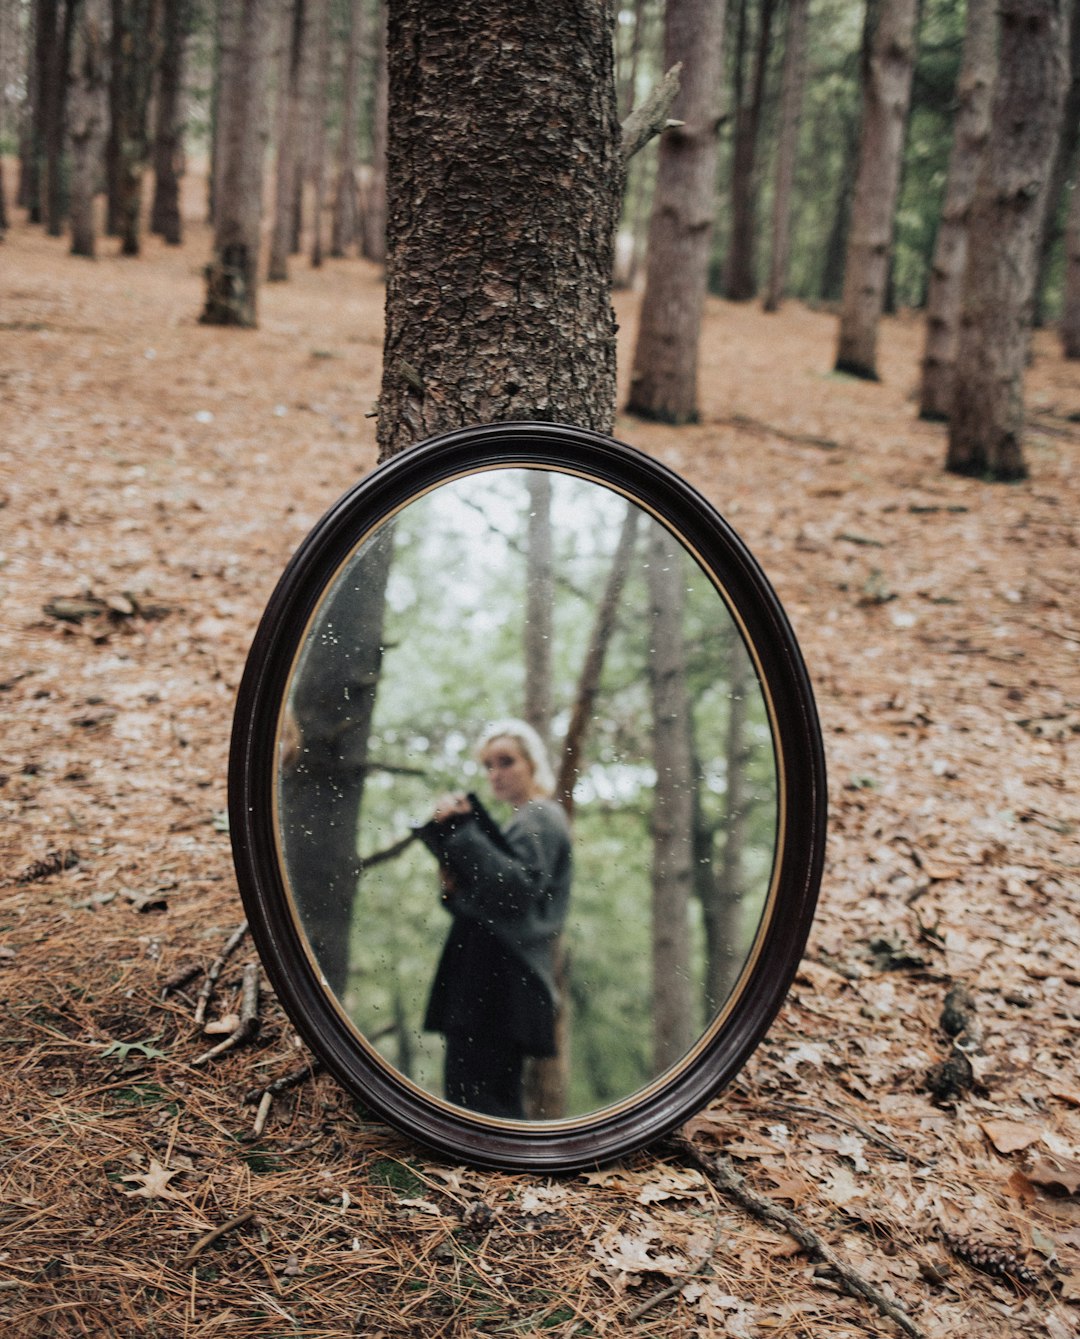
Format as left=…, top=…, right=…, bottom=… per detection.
left=379, top=0, right=622, bottom=459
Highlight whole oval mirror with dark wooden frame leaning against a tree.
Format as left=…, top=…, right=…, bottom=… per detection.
left=230, top=423, right=824, bottom=1169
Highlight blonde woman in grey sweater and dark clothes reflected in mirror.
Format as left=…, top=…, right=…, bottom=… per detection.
left=419, top=720, right=570, bottom=1121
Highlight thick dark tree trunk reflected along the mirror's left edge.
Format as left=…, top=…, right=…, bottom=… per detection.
left=281, top=525, right=393, bottom=998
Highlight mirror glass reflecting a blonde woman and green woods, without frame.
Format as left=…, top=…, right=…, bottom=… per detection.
left=277, top=469, right=779, bottom=1121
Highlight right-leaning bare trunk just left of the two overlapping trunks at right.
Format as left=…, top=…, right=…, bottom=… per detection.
left=836, top=0, right=918, bottom=382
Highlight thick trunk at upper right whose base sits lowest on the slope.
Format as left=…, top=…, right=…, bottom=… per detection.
left=946, top=0, right=1068, bottom=479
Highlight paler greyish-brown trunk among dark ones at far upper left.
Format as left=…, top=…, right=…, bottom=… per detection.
left=68, top=0, right=108, bottom=258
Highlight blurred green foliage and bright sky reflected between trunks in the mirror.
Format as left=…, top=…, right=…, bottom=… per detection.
left=282, top=470, right=776, bottom=1114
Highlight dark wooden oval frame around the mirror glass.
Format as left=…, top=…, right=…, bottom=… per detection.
left=229, top=423, right=826, bottom=1172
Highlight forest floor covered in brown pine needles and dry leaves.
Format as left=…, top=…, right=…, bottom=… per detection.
left=0, top=195, right=1080, bottom=1339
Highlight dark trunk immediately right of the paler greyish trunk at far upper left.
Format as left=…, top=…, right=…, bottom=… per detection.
left=112, top=0, right=159, bottom=256
